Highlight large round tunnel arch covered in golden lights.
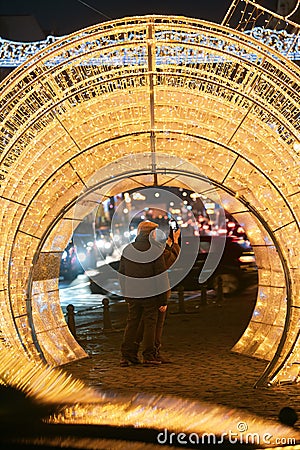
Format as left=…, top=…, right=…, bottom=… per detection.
left=0, top=16, right=300, bottom=394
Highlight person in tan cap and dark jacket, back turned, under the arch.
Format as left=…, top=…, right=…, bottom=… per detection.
left=119, top=221, right=169, bottom=366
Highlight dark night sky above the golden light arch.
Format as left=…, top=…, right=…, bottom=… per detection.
left=0, top=0, right=277, bottom=36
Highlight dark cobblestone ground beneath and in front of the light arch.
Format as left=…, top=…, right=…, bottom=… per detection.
left=65, top=287, right=300, bottom=425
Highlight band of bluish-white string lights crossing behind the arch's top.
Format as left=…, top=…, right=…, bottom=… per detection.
left=0, top=27, right=300, bottom=68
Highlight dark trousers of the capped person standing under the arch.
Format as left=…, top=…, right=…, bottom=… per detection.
left=121, top=299, right=158, bottom=360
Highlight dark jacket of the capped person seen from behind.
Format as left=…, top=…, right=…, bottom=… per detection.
left=119, top=233, right=169, bottom=306
